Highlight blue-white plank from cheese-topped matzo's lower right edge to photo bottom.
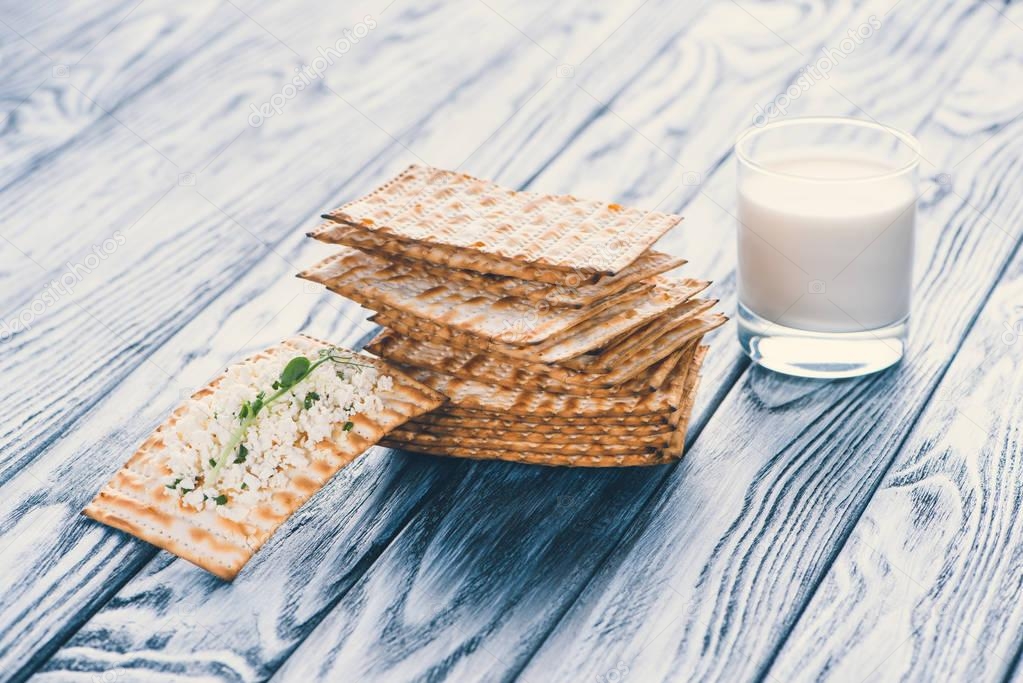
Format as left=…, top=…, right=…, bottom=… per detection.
left=35, top=449, right=456, bottom=681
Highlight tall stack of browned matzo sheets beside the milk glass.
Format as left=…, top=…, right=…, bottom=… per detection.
left=300, top=166, right=725, bottom=466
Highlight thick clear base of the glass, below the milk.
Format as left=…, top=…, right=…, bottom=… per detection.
left=738, top=304, right=909, bottom=379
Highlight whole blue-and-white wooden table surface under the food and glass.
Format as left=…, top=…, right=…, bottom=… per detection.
left=0, top=0, right=1023, bottom=683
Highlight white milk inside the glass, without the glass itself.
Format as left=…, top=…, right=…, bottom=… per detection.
left=738, top=155, right=917, bottom=332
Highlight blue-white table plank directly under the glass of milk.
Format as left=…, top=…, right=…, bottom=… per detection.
left=524, top=7, right=1023, bottom=680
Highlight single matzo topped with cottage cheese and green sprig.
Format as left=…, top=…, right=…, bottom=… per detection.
left=83, top=335, right=444, bottom=581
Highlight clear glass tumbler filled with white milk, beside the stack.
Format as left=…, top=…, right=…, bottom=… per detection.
left=736, top=117, right=920, bottom=378
